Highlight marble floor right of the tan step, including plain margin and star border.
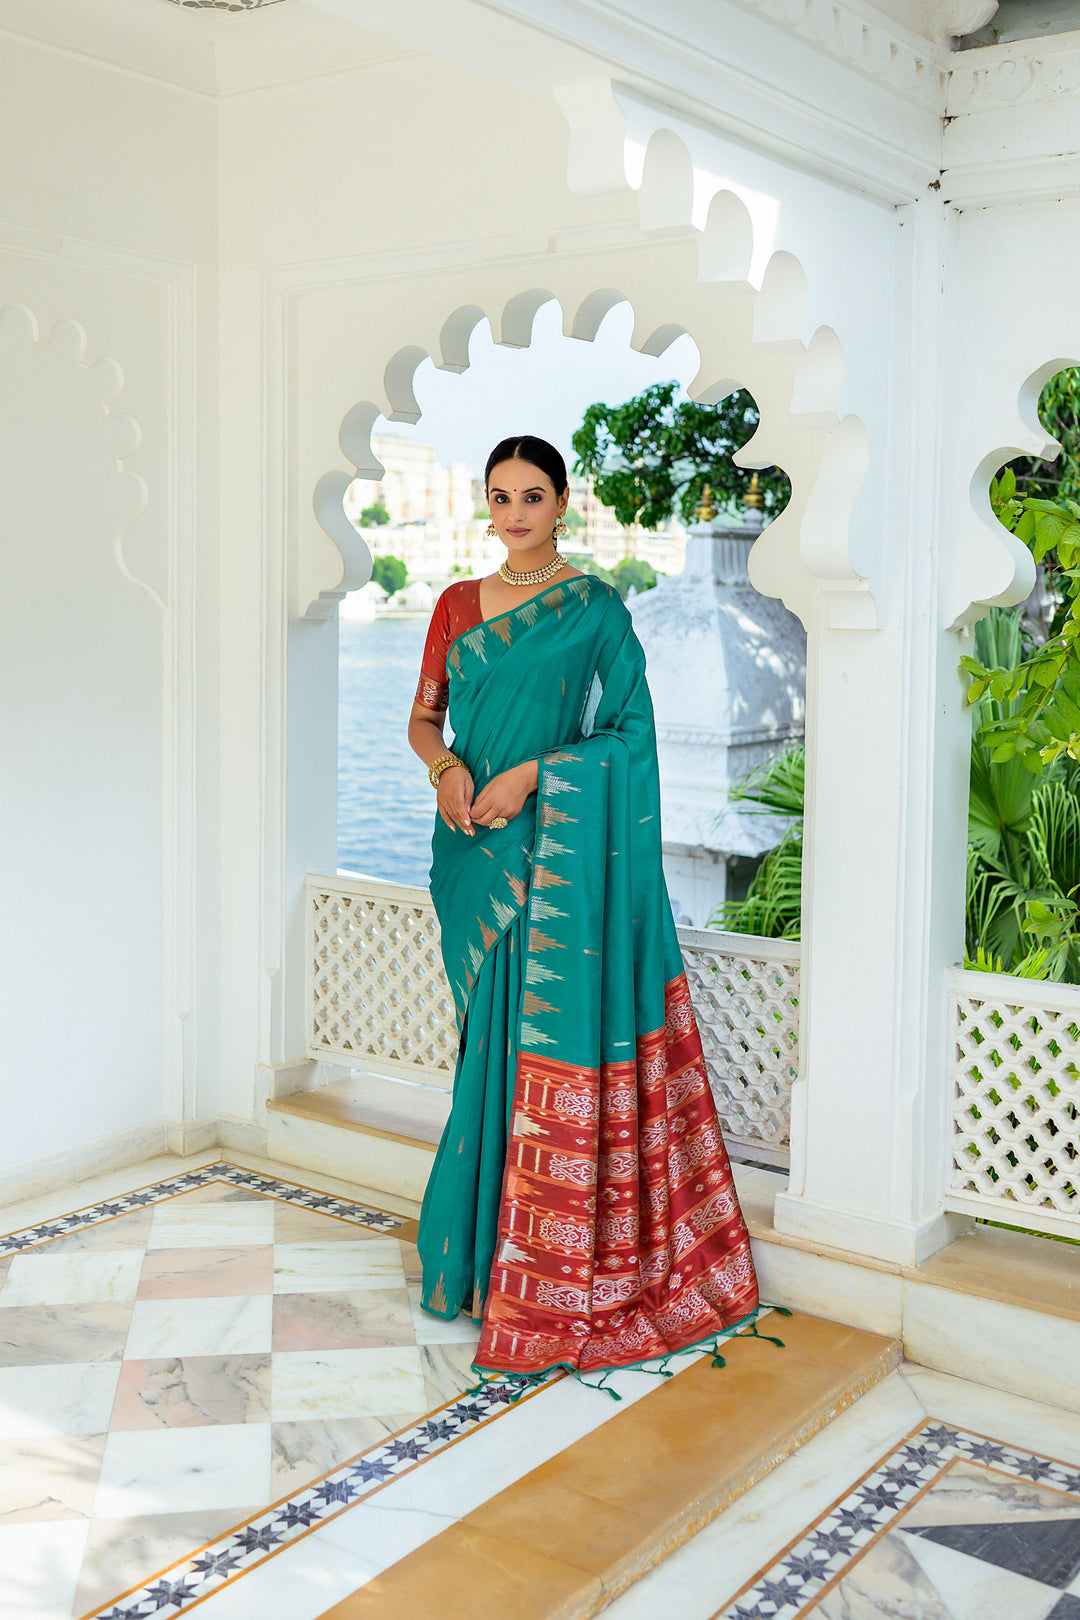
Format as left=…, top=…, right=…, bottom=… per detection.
left=604, top=1364, right=1080, bottom=1620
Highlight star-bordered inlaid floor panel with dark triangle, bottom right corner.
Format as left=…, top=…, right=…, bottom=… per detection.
left=714, top=1422, right=1080, bottom=1620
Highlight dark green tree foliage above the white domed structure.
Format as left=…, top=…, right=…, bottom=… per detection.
left=570, top=382, right=792, bottom=528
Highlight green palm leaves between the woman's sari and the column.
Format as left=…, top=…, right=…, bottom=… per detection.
left=709, top=747, right=806, bottom=940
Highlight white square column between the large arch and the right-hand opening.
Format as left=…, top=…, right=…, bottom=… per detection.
left=776, top=203, right=970, bottom=1265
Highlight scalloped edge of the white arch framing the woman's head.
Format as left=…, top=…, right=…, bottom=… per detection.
left=300, top=247, right=878, bottom=629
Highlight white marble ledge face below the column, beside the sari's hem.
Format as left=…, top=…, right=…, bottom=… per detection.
left=750, top=1231, right=904, bottom=1338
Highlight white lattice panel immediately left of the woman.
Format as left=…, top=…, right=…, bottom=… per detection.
left=308, top=878, right=458, bottom=1087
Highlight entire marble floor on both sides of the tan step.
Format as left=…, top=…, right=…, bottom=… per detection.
left=8, top=1153, right=1080, bottom=1620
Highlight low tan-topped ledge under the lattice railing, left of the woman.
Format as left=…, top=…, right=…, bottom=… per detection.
left=267, top=1072, right=450, bottom=1202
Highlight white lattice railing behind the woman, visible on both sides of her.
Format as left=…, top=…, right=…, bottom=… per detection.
left=308, top=876, right=798, bottom=1165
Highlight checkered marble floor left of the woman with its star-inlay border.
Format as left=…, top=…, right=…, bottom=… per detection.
left=0, top=1163, right=544, bottom=1620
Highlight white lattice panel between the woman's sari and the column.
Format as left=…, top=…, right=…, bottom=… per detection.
left=678, top=928, right=800, bottom=1165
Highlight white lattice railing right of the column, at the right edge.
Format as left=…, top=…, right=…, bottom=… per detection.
left=946, top=969, right=1080, bottom=1238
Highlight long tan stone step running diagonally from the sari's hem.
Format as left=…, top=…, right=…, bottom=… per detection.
left=321, top=1315, right=902, bottom=1620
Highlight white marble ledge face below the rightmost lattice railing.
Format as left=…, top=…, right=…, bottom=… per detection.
left=904, top=1281, right=1080, bottom=1413
